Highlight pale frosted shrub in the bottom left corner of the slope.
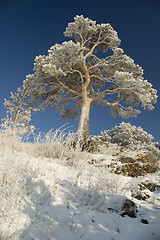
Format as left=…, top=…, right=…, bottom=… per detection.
left=0, top=156, right=33, bottom=239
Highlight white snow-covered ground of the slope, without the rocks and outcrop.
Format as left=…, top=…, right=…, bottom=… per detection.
left=0, top=134, right=160, bottom=240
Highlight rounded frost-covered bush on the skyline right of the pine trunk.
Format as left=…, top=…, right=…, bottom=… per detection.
left=101, top=122, right=159, bottom=155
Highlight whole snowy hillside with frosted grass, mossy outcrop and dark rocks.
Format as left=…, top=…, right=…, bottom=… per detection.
left=0, top=124, right=160, bottom=240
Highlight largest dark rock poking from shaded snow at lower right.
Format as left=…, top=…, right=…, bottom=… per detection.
left=121, top=199, right=138, bottom=218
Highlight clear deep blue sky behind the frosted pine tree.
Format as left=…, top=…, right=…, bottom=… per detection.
left=0, top=0, right=160, bottom=141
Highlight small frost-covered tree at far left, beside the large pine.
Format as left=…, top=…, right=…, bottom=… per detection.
left=1, top=74, right=35, bottom=138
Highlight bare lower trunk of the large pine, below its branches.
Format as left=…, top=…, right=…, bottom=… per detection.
left=77, top=98, right=91, bottom=146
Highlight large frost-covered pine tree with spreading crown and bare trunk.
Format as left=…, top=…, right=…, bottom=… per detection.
left=4, top=15, right=157, bottom=143
